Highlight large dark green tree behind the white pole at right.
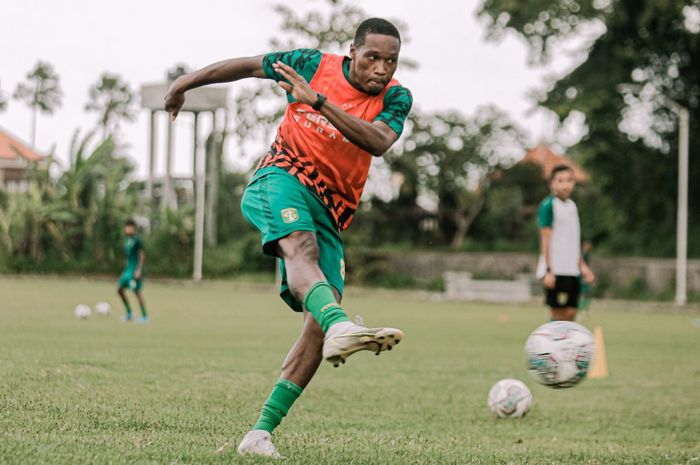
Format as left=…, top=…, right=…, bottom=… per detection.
left=480, top=0, right=700, bottom=255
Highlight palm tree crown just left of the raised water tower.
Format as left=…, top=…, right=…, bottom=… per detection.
left=85, top=73, right=135, bottom=140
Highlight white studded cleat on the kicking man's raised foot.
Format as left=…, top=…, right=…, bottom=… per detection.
left=323, top=323, right=403, bottom=367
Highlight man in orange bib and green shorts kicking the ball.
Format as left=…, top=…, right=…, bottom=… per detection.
left=165, top=18, right=412, bottom=458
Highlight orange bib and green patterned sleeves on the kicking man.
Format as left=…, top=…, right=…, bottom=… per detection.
left=256, top=49, right=413, bottom=230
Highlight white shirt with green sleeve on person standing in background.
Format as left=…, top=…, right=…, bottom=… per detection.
left=537, top=195, right=581, bottom=276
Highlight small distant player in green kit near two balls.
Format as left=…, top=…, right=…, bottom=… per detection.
left=117, top=220, right=148, bottom=323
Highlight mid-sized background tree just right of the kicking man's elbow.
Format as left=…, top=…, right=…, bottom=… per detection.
left=386, top=107, right=525, bottom=250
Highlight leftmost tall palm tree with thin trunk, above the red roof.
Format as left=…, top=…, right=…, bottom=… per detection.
left=13, top=61, right=63, bottom=147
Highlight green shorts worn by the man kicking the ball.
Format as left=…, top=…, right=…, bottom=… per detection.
left=241, top=167, right=345, bottom=312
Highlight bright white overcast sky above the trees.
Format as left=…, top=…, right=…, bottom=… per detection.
left=0, top=0, right=588, bottom=177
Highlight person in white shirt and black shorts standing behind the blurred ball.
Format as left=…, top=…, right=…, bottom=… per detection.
left=537, top=165, right=595, bottom=321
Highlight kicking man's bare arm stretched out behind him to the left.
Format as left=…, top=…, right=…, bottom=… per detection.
left=165, top=55, right=265, bottom=121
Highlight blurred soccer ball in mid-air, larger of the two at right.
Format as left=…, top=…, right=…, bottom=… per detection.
left=525, top=321, right=595, bottom=388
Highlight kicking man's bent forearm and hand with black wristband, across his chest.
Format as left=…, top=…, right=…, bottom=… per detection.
left=272, top=61, right=398, bottom=157
